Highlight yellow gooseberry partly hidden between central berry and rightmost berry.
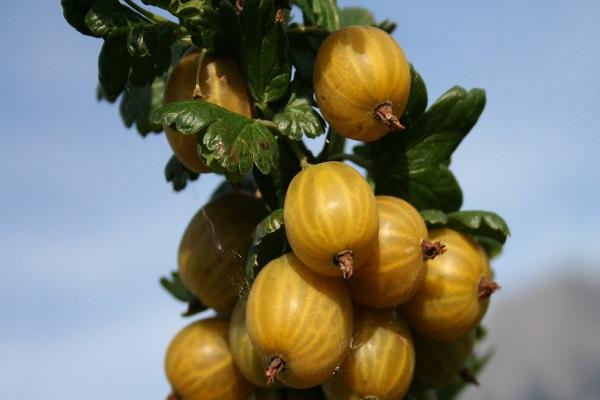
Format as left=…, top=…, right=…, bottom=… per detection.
left=348, top=196, right=428, bottom=308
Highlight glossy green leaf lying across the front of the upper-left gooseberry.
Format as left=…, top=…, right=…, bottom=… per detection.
left=151, top=100, right=278, bottom=175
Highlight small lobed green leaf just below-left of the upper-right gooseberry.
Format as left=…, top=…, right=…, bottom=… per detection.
left=273, top=82, right=325, bottom=140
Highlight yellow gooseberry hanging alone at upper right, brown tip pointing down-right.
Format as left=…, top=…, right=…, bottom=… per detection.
left=313, top=26, right=410, bottom=142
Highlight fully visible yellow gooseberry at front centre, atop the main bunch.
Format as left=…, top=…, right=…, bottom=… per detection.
left=283, top=161, right=379, bottom=277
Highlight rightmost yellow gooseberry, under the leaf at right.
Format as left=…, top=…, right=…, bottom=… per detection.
left=401, top=229, right=492, bottom=341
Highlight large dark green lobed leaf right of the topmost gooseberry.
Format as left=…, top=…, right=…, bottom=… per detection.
left=355, top=83, right=485, bottom=212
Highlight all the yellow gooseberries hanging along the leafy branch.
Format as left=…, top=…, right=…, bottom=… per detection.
left=165, top=27, right=498, bottom=400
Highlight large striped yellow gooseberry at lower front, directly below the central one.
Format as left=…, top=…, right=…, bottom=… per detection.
left=246, top=253, right=352, bottom=389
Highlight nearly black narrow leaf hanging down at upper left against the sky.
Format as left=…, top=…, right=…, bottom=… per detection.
left=98, top=37, right=131, bottom=101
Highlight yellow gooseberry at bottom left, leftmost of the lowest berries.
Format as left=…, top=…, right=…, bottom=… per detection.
left=165, top=318, right=253, bottom=400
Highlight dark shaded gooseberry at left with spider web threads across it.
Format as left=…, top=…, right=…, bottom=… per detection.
left=178, top=193, right=267, bottom=312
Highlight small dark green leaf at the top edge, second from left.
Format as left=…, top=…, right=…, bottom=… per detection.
left=85, top=0, right=142, bottom=38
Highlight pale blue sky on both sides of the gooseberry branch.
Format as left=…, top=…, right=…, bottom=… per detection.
left=0, top=0, right=600, bottom=400
